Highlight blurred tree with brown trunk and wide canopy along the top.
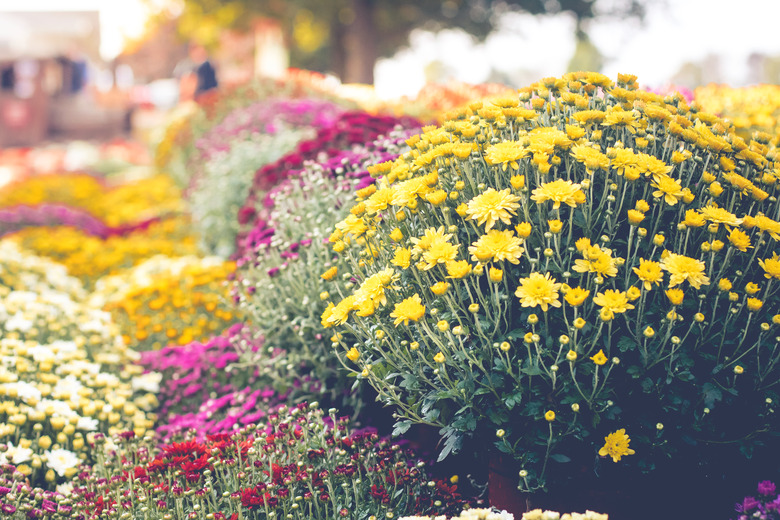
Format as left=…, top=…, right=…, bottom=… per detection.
left=163, top=0, right=649, bottom=84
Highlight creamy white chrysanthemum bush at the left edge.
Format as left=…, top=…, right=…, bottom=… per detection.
left=0, top=242, right=159, bottom=487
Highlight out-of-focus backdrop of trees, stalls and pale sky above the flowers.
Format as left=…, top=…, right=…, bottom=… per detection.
left=0, top=0, right=780, bottom=147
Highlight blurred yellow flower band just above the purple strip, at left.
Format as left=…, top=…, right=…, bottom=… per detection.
left=0, top=174, right=183, bottom=226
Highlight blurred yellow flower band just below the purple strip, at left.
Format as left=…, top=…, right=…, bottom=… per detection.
left=9, top=217, right=197, bottom=287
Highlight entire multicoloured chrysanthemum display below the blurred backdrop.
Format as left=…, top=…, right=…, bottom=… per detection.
left=0, top=72, right=780, bottom=520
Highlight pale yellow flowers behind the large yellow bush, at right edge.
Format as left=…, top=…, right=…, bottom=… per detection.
left=694, top=84, right=780, bottom=145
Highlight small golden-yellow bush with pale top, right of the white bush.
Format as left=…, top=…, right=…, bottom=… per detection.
left=101, top=256, right=241, bottom=350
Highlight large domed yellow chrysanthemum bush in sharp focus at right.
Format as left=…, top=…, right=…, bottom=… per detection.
left=322, top=73, right=780, bottom=490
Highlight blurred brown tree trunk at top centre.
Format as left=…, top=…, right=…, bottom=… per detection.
left=341, top=0, right=377, bottom=85
